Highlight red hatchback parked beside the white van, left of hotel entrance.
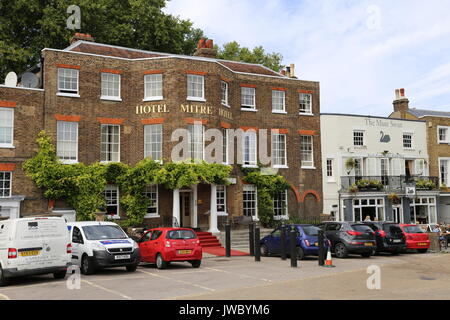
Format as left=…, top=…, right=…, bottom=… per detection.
left=138, top=228, right=202, bottom=269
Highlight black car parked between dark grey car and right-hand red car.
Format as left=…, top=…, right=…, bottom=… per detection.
left=363, top=221, right=406, bottom=254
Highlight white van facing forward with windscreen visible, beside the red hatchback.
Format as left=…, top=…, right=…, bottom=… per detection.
left=67, top=221, right=141, bottom=274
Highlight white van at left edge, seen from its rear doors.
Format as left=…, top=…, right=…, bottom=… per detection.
left=0, top=217, right=71, bottom=286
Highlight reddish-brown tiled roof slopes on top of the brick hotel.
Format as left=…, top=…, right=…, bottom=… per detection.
left=66, top=41, right=285, bottom=77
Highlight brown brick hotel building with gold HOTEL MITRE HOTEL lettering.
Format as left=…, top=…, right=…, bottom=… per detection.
left=0, top=34, right=322, bottom=232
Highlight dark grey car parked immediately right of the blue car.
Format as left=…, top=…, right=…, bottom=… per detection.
left=319, top=221, right=376, bottom=258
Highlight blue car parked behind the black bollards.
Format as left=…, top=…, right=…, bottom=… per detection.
left=261, top=224, right=330, bottom=260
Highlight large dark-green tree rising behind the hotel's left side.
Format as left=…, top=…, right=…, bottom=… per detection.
left=0, top=0, right=203, bottom=83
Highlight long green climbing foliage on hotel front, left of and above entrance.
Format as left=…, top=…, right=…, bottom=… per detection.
left=23, top=131, right=232, bottom=225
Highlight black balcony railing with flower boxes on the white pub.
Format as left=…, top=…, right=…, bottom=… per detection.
left=341, top=175, right=439, bottom=192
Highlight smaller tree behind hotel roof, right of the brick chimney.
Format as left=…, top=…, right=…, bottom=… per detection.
left=216, top=41, right=283, bottom=72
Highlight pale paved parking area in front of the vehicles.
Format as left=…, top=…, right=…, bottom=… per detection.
left=0, top=253, right=450, bottom=300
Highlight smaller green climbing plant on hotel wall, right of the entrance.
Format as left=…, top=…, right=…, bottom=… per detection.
left=242, top=168, right=290, bottom=227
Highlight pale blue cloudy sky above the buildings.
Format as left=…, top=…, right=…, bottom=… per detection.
left=165, top=0, right=450, bottom=116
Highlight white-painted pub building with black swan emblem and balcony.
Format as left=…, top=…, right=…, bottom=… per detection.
left=320, top=114, right=439, bottom=223
